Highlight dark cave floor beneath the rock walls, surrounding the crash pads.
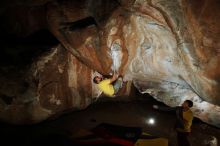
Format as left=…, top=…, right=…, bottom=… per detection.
left=0, top=96, right=220, bottom=146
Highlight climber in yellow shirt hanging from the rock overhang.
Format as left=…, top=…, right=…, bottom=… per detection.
left=93, top=74, right=123, bottom=96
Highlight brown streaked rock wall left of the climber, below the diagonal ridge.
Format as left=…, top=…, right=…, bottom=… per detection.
left=0, top=46, right=96, bottom=124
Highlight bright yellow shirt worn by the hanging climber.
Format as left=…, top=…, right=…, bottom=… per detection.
left=98, top=79, right=114, bottom=96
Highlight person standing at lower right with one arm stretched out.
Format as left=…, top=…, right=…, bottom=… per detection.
left=153, top=100, right=193, bottom=146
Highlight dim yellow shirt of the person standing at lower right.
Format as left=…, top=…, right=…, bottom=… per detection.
left=177, top=109, right=193, bottom=132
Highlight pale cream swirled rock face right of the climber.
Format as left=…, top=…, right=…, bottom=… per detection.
left=122, top=1, right=220, bottom=126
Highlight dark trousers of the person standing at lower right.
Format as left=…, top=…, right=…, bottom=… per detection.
left=177, top=131, right=191, bottom=146
